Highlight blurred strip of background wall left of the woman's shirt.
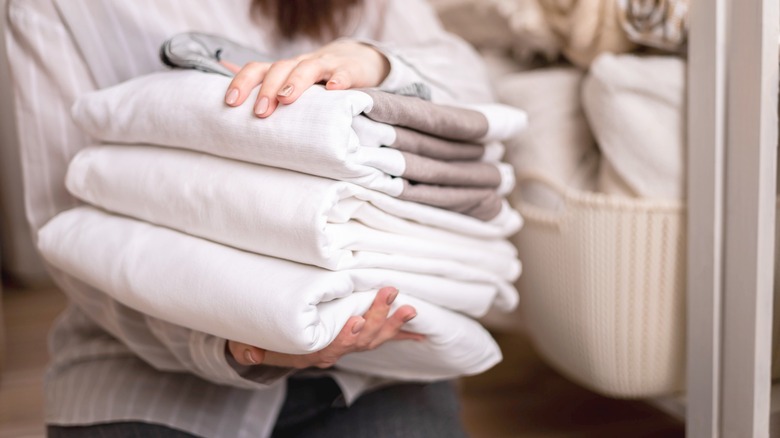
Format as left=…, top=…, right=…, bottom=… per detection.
left=0, top=0, right=47, bottom=285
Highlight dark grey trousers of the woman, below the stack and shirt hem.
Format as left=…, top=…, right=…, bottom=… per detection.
left=48, top=377, right=467, bottom=438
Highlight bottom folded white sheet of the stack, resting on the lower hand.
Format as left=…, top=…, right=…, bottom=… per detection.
left=39, top=207, right=501, bottom=380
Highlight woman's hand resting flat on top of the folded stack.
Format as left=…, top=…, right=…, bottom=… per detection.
left=222, top=40, right=390, bottom=117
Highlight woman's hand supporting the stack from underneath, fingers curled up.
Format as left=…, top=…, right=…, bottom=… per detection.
left=228, top=287, right=425, bottom=368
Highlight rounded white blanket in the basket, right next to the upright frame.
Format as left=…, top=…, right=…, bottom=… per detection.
left=582, top=54, right=686, bottom=199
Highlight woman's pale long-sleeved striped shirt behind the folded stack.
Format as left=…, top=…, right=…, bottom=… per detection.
left=6, top=0, right=492, bottom=437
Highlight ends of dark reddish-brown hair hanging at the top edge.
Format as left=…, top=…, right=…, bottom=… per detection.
left=252, top=0, right=363, bottom=39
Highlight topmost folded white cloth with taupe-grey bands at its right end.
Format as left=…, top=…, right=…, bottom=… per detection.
left=73, top=70, right=525, bottom=222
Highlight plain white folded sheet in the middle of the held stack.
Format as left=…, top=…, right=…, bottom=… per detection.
left=66, top=145, right=520, bottom=296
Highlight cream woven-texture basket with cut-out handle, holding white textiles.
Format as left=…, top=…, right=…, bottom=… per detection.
left=513, top=170, right=778, bottom=398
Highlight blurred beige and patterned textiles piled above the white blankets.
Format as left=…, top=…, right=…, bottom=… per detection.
left=431, top=0, right=690, bottom=68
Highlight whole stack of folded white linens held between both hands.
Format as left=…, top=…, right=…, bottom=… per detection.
left=39, top=71, right=525, bottom=380
